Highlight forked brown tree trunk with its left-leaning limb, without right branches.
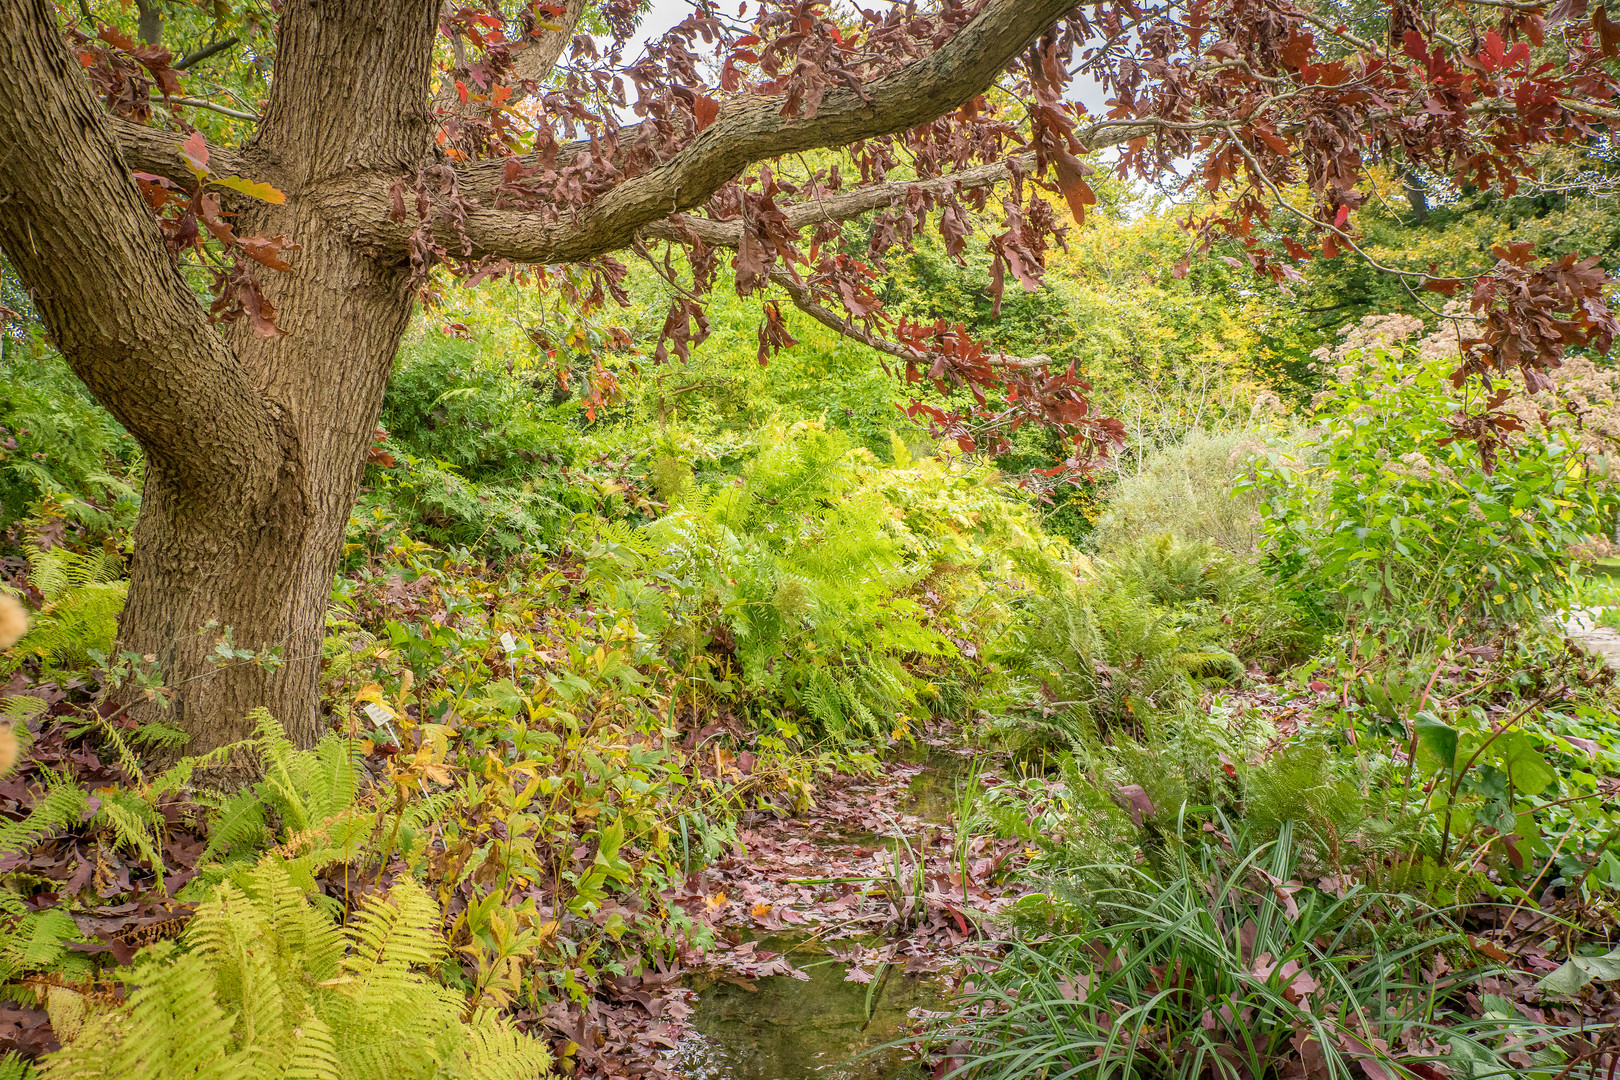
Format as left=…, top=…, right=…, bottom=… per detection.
left=0, top=0, right=437, bottom=753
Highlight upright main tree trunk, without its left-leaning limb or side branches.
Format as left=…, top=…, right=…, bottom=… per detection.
left=118, top=0, right=437, bottom=753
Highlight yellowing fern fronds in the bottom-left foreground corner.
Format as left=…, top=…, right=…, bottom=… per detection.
left=41, top=855, right=551, bottom=1080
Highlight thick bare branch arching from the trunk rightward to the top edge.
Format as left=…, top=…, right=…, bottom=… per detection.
left=356, top=0, right=1072, bottom=262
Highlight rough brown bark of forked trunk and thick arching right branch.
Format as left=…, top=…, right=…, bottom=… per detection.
left=0, top=0, right=1071, bottom=753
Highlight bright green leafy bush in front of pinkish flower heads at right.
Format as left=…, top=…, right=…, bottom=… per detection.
left=1241, top=348, right=1615, bottom=623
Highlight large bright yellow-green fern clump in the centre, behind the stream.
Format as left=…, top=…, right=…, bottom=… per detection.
left=585, top=423, right=1053, bottom=737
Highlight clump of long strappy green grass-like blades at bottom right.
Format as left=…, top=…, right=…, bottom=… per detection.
left=935, top=823, right=1589, bottom=1080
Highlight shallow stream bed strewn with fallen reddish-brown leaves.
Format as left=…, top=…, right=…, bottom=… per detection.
left=554, top=676, right=1620, bottom=1080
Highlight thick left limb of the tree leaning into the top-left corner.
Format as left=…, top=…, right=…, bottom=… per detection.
left=0, top=0, right=280, bottom=500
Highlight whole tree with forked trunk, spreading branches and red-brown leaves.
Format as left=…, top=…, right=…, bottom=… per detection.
left=0, top=0, right=1620, bottom=745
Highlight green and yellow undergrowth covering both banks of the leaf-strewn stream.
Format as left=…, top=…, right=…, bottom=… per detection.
left=0, top=241, right=1620, bottom=1080
